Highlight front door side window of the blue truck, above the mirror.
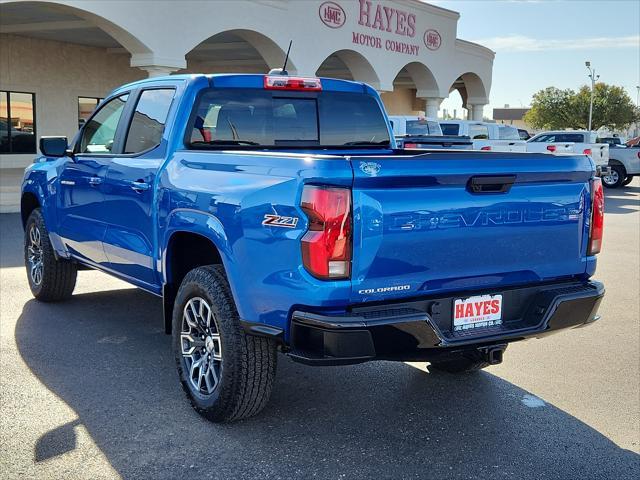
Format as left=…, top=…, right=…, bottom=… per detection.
left=80, top=94, right=129, bottom=153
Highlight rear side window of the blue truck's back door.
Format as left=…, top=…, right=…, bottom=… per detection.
left=124, top=88, right=175, bottom=153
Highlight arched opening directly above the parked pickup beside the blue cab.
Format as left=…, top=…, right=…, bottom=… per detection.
left=381, top=62, right=439, bottom=115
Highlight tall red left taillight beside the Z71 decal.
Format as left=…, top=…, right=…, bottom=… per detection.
left=301, top=185, right=352, bottom=280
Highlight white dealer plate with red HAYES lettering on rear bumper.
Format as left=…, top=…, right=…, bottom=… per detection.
left=453, top=295, right=502, bottom=331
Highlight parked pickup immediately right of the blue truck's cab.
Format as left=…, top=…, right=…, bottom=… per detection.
left=389, top=115, right=472, bottom=150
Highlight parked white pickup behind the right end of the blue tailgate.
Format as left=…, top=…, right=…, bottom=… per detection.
left=527, top=130, right=609, bottom=173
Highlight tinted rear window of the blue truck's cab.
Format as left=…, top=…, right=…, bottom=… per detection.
left=190, top=89, right=390, bottom=148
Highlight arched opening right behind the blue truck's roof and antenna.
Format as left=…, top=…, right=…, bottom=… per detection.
left=185, top=30, right=296, bottom=73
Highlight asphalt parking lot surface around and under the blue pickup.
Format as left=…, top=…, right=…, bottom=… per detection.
left=0, top=178, right=640, bottom=479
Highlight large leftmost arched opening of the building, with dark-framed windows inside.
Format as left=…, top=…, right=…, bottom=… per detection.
left=0, top=1, right=151, bottom=143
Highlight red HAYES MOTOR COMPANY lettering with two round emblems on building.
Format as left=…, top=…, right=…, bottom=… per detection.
left=318, top=0, right=442, bottom=56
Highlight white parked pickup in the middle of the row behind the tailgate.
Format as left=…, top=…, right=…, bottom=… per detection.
left=440, top=120, right=527, bottom=152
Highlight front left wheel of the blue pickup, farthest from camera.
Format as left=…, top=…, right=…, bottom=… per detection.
left=24, top=208, right=78, bottom=302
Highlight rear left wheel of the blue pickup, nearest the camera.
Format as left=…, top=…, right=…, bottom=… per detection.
left=172, top=265, right=277, bottom=422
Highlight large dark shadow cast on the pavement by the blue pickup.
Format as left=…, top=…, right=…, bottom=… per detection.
left=15, top=290, right=639, bottom=479
